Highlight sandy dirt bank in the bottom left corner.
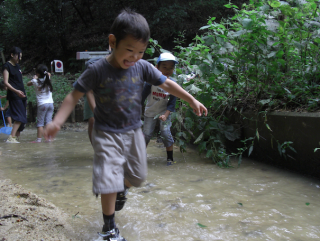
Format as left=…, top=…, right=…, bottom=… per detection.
left=0, top=179, right=79, bottom=241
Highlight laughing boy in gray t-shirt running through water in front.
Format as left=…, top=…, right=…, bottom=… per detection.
left=45, top=10, right=207, bottom=241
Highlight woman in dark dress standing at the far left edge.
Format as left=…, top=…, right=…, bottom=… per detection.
left=2, top=47, right=27, bottom=143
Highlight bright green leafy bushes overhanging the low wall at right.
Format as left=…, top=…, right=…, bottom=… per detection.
left=168, top=0, right=320, bottom=167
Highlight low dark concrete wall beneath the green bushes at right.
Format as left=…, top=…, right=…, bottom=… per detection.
left=232, top=112, right=320, bottom=177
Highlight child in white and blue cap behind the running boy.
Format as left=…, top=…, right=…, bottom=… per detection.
left=141, top=53, right=178, bottom=166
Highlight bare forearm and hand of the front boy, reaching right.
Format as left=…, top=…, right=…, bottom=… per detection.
left=159, top=79, right=208, bottom=116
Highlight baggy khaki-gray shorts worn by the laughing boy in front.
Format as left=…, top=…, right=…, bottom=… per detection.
left=92, top=128, right=147, bottom=194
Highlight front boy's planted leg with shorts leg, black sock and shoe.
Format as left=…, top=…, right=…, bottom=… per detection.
left=92, top=129, right=126, bottom=241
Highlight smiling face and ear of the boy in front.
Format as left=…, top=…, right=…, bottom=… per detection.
left=108, top=34, right=148, bottom=69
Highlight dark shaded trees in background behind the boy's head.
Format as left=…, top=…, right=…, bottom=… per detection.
left=0, top=0, right=245, bottom=71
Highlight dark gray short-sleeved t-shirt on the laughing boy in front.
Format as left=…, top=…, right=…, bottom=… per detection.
left=74, top=58, right=167, bottom=133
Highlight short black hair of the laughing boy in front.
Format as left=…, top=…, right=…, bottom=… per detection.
left=110, top=8, right=150, bottom=44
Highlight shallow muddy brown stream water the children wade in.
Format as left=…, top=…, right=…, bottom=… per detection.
left=0, top=129, right=320, bottom=241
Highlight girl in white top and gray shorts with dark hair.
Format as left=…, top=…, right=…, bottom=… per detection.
left=27, top=64, right=54, bottom=143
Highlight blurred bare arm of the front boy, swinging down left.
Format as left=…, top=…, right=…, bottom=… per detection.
left=44, top=90, right=84, bottom=140
